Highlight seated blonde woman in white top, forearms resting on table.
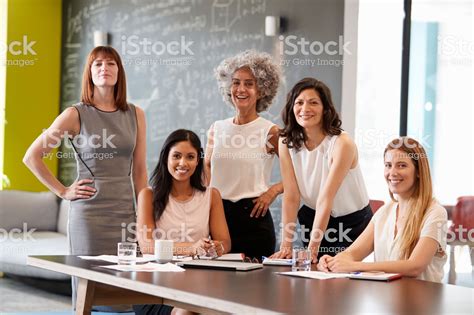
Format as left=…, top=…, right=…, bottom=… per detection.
left=318, top=137, right=447, bottom=282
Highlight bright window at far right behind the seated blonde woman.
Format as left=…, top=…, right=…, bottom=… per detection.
left=407, top=0, right=474, bottom=204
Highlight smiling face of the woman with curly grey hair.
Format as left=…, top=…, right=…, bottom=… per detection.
left=230, top=68, right=259, bottom=110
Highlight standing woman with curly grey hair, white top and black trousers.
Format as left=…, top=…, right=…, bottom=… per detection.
left=206, top=50, right=283, bottom=259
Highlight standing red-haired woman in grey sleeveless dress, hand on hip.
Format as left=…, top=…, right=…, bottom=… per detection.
left=24, top=46, right=147, bottom=311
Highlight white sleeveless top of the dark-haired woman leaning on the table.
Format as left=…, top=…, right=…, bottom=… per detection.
left=289, top=136, right=369, bottom=217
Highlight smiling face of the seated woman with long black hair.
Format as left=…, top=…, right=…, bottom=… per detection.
left=168, top=141, right=199, bottom=181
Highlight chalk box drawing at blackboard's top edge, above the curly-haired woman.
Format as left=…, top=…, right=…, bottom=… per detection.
left=211, top=0, right=241, bottom=32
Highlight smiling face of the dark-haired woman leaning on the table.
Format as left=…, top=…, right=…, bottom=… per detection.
left=293, top=89, right=324, bottom=129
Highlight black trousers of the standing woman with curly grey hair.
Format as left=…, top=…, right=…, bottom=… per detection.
left=222, top=198, right=276, bottom=260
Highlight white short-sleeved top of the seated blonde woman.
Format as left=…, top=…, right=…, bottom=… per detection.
left=372, top=202, right=448, bottom=282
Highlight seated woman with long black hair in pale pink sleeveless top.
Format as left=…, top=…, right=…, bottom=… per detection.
left=134, top=129, right=231, bottom=315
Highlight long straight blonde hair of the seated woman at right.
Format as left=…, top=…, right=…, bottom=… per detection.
left=384, top=137, right=433, bottom=260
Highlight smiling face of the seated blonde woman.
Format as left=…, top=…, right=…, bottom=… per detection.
left=384, top=149, right=417, bottom=200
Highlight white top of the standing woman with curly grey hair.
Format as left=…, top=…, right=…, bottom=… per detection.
left=210, top=117, right=275, bottom=202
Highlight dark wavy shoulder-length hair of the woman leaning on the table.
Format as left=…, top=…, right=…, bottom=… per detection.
left=280, top=78, right=342, bottom=151
